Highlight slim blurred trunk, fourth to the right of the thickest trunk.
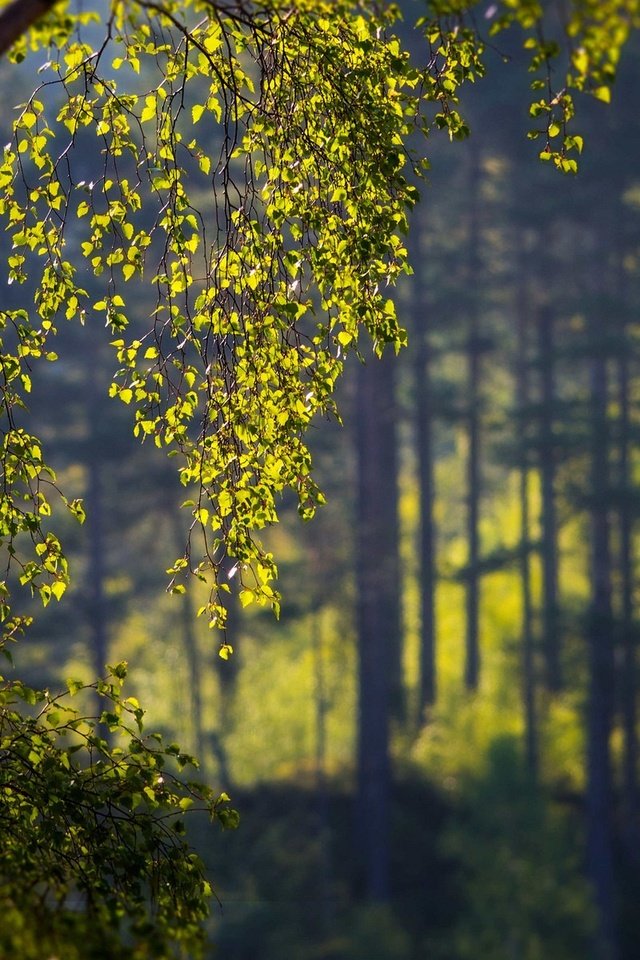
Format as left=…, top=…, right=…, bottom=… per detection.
left=538, top=305, right=562, bottom=692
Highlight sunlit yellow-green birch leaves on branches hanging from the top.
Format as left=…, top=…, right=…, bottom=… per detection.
left=0, top=0, right=633, bottom=632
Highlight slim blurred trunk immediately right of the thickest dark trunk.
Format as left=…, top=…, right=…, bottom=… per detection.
left=413, top=233, right=437, bottom=723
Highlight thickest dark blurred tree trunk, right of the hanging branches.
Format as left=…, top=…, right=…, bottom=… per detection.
left=356, top=355, right=401, bottom=900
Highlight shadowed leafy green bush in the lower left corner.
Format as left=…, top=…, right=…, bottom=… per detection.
left=0, top=663, right=237, bottom=960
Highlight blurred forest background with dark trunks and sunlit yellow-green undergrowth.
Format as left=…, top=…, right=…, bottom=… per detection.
left=0, top=3, right=640, bottom=960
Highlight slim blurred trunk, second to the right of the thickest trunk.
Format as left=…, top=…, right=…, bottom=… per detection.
left=464, top=147, right=482, bottom=690
